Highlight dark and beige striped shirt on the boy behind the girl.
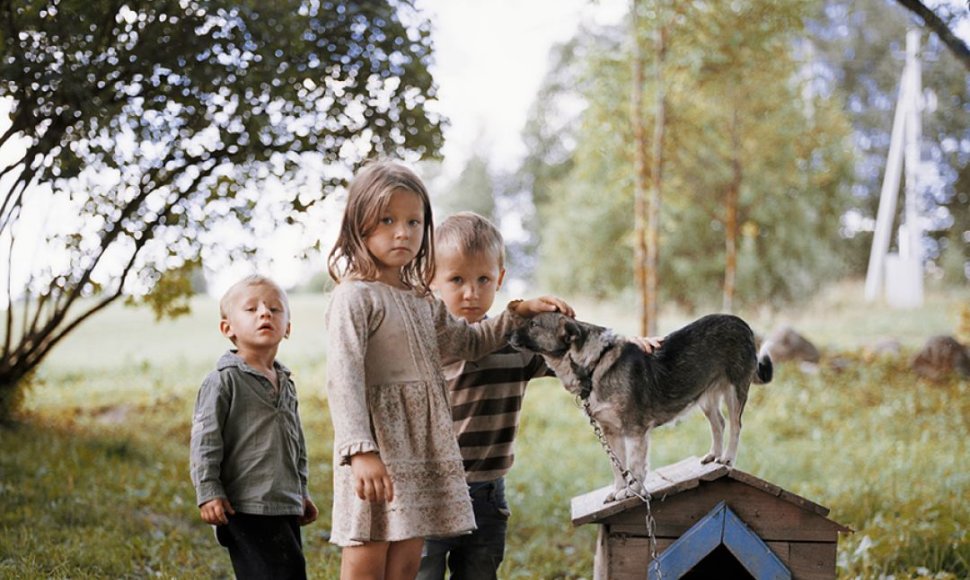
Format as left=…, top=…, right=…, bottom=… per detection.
left=443, top=346, right=554, bottom=483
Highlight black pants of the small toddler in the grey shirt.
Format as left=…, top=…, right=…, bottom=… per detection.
left=216, top=513, right=306, bottom=580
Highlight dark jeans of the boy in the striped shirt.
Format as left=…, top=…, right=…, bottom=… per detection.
left=417, top=478, right=509, bottom=580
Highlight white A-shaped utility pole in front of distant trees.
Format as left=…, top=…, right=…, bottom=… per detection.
left=866, top=30, right=923, bottom=308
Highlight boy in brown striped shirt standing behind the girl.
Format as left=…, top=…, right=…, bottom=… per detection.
left=418, top=212, right=560, bottom=580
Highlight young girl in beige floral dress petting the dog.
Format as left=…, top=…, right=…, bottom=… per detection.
left=327, top=161, right=572, bottom=579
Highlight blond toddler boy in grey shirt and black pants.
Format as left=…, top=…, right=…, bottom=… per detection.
left=190, top=275, right=318, bottom=578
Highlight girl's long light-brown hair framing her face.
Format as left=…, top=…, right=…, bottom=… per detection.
left=327, top=160, right=434, bottom=294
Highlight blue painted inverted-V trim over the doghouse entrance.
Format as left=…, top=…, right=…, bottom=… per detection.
left=647, top=501, right=791, bottom=580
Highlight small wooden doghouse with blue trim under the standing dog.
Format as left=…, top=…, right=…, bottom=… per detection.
left=572, top=457, right=851, bottom=580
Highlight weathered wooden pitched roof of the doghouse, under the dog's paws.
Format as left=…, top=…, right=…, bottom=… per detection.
left=572, top=457, right=849, bottom=531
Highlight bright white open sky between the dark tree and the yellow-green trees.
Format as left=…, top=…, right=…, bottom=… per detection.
left=417, top=0, right=629, bottom=176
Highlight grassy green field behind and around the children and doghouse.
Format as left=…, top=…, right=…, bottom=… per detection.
left=0, top=284, right=970, bottom=578
